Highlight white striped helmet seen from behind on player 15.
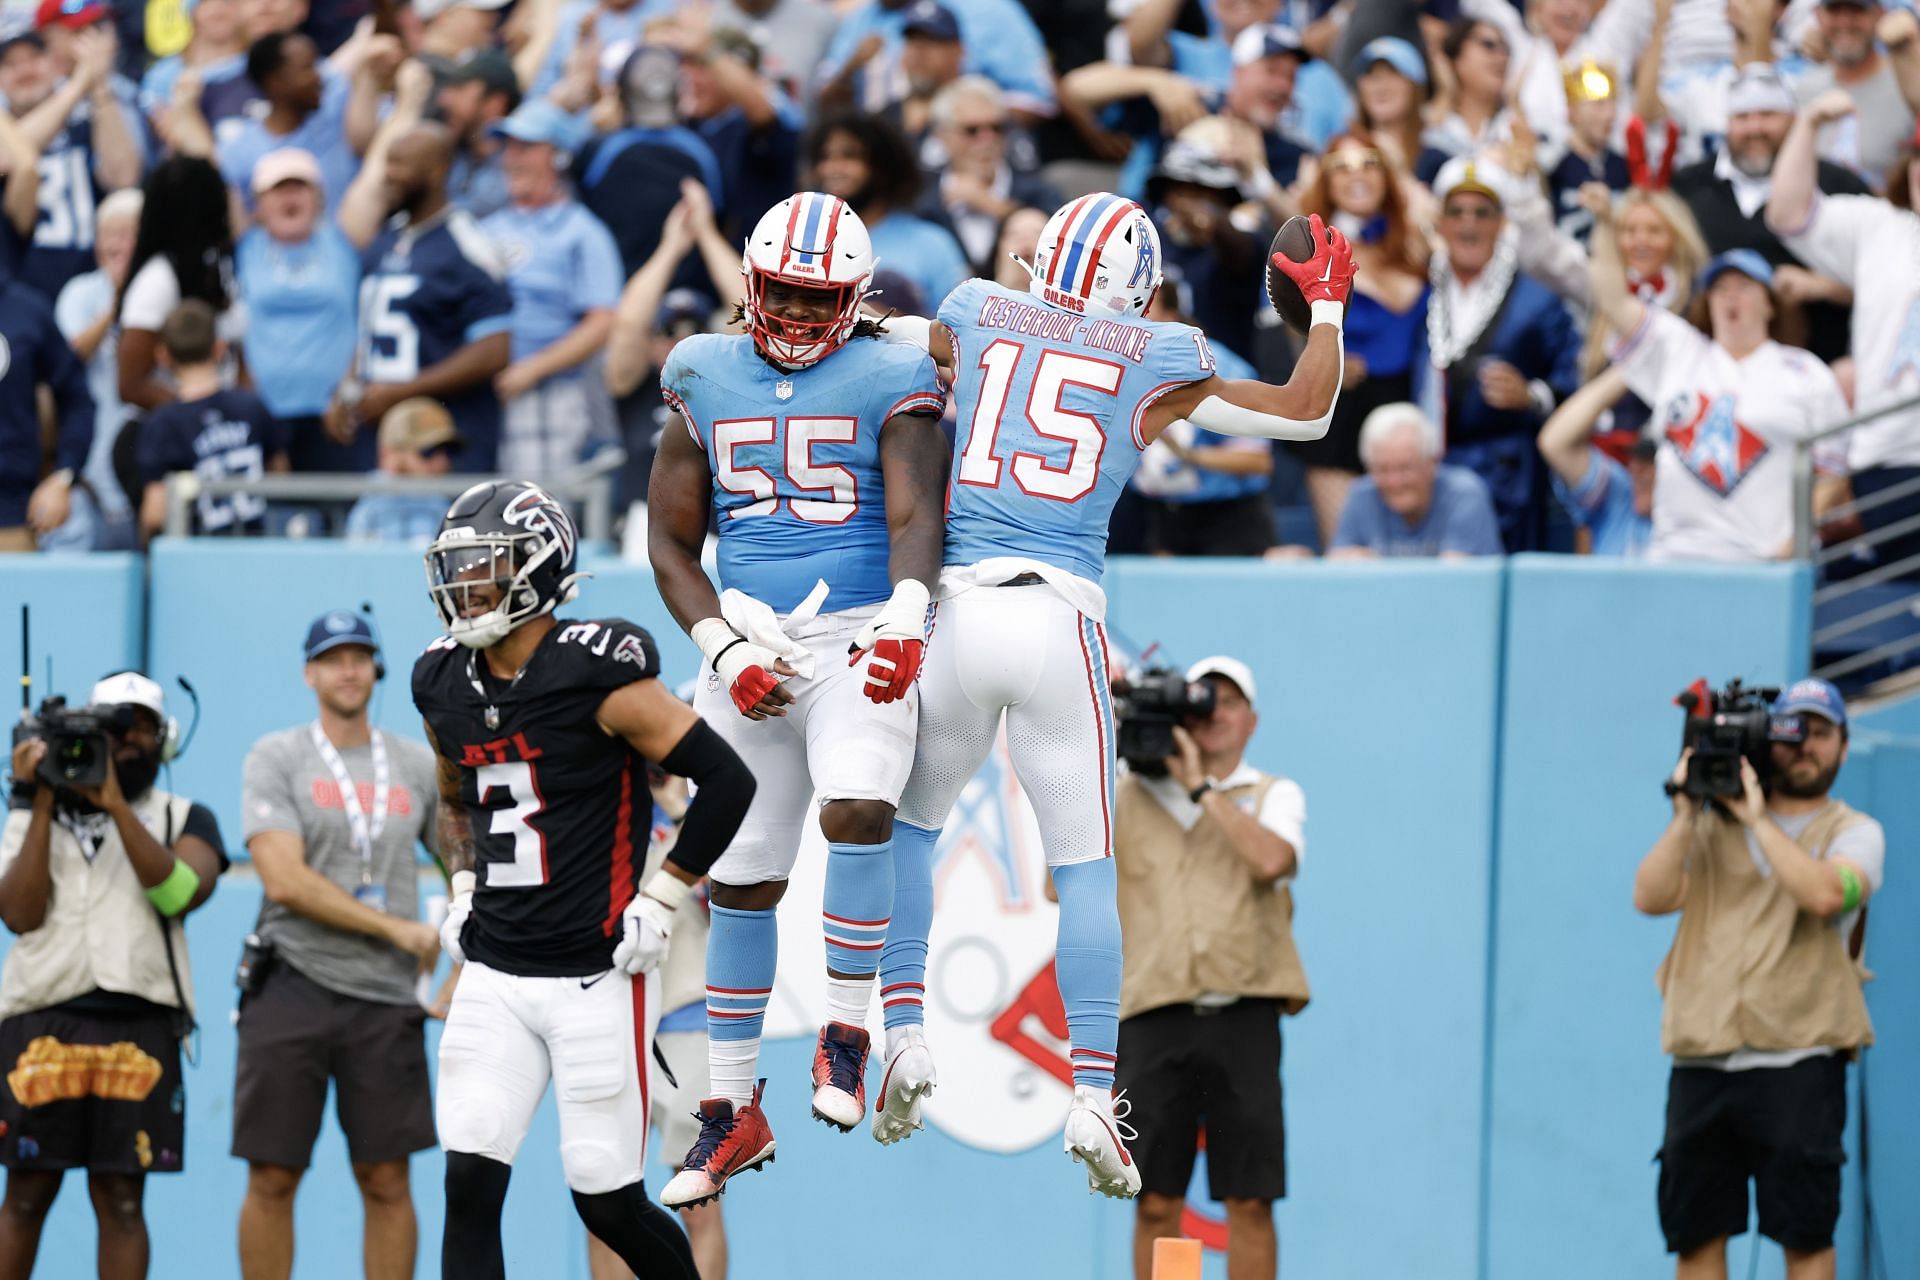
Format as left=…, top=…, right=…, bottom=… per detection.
left=1029, top=192, right=1162, bottom=317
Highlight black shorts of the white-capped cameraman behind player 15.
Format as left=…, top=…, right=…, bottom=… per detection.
left=1114, top=1000, right=1286, bottom=1199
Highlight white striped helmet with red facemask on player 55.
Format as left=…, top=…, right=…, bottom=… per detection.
left=739, top=192, right=874, bottom=368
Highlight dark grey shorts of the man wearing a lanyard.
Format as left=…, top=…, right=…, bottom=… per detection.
left=232, top=960, right=434, bottom=1169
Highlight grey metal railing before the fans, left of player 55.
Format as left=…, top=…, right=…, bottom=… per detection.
left=163, top=449, right=626, bottom=541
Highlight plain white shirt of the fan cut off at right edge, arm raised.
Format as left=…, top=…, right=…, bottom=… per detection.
left=1780, top=192, right=1920, bottom=470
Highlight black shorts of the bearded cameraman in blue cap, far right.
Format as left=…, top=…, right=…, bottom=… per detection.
left=1659, top=1055, right=1847, bottom=1253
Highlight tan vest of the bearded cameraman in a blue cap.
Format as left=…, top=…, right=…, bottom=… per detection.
left=1655, top=800, right=1874, bottom=1057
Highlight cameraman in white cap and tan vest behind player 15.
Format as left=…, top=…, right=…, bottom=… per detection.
left=1114, top=658, right=1308, bottom=1280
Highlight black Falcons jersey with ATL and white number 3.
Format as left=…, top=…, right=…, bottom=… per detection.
left=413, top=618, right=660, bottom=977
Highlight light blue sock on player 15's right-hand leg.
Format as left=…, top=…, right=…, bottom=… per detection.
left=1054, top=858, right=1121, bottom=1092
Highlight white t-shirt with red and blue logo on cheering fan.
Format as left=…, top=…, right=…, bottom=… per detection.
left=1613, top=307, right=1847, bottom=560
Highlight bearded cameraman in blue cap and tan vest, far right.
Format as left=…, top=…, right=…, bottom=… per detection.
left=1634, top=679, right=1885, bottom=1280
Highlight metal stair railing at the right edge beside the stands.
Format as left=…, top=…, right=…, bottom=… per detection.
left=1793, top=395, right=1920, bottom=679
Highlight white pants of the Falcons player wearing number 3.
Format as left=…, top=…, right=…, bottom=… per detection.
left=434, top=961, right=660, bottom=1196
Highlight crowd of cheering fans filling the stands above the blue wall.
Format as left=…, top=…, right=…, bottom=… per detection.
left=0, top=0, right=1920, bottom=568
